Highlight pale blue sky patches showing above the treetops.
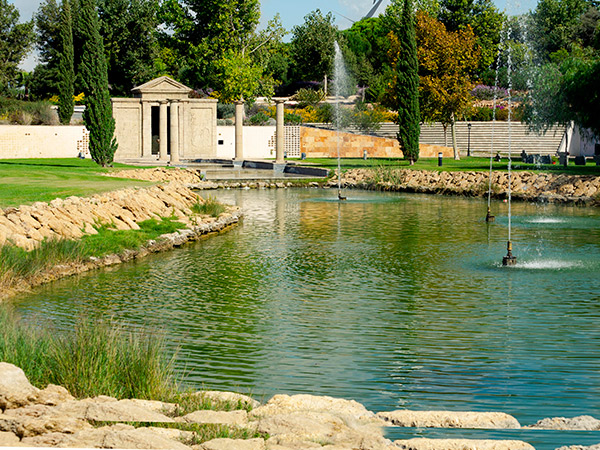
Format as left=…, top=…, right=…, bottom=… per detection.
left=8, top=0, right=537, bottom=70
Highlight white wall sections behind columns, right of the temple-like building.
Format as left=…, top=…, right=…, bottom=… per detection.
left=217, top=126, right=275, bottom=159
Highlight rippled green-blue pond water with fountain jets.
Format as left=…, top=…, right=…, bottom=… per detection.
left=12, top=189, right=600, bottom=449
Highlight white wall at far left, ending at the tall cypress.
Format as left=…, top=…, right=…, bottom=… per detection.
left=0, top=125, right=89, bottom=159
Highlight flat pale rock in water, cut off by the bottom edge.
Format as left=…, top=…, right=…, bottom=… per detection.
left=394, top=438, right=535, bottom=450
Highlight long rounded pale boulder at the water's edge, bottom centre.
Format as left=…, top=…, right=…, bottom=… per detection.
left=250, top=394, right=375, bottom=421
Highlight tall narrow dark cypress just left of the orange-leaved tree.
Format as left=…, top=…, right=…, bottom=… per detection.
left=396, top=0, right=421, bottom=165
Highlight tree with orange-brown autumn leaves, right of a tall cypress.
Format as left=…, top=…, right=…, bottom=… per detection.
left=417, top=12, right=480, bottom=159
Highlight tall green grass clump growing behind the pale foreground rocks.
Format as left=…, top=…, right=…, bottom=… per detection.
left=0, top=305, right=178, bottom=399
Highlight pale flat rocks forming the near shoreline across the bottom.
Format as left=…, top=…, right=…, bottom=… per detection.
left=0, top=362, right=600, bottom=450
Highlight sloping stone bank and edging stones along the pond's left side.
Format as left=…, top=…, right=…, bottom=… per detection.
left=0, top=182, right=241, bottom=300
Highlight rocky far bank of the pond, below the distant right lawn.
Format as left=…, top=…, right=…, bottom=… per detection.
left=104, top=167, right=600, bottom=206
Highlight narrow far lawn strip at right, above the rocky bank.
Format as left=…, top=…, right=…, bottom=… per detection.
left=296, top=155, right=600, bottom=175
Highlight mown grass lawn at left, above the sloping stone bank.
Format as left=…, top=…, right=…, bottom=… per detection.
left=0, top=158, right=152, bottom=208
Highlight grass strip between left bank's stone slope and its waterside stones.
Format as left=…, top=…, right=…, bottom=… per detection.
left=0, top=217, right=186, bottom=286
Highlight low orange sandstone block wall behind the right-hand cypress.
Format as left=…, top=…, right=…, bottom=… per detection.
left=300, top=127, right=454, bottom=158
